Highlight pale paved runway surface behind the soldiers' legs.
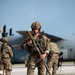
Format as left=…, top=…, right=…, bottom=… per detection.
left=9, top=64, right=75, bottom=75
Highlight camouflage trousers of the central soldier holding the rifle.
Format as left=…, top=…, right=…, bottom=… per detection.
left=27, top=55, right=45, bottom=75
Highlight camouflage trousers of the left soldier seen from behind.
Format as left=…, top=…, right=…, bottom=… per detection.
left=0, top=59, right=12, bottom=75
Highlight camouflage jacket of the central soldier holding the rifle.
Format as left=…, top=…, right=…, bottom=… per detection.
left=22, top=31, right=49, bottom=54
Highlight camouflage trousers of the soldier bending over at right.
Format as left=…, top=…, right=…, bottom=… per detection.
left=46, top=55, right=59, bottom=75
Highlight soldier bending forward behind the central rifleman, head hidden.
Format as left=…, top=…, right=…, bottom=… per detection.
left=46, top=42, right=60, bottom=75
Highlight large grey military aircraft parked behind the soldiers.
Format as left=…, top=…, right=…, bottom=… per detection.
left=2, top=25, right=75, bottom=63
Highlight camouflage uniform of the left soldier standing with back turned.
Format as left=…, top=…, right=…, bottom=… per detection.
left=0, top=44, right=13, bottom=75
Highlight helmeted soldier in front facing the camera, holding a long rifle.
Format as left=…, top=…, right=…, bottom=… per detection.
left=22, top=22, right=49, bottom=75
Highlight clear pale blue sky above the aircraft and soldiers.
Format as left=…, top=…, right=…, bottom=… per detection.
left=0, top=0, right=75, bottom=37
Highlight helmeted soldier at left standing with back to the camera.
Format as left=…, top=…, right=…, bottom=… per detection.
left=0, top=37, right=13, bottom=75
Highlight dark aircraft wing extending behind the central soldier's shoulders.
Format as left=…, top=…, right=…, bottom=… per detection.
left=16, top=31, right=63, bottom=42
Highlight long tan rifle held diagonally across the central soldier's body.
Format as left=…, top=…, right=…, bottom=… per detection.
left=27, top=31, right=51, bottom=75
